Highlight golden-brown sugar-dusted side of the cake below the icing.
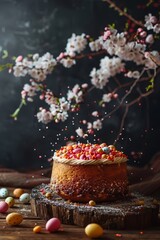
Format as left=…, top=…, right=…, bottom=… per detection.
left=51, top=161, right=128, bottom=202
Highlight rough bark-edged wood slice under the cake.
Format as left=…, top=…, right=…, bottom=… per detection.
left=31, top=184, right=159, bottom=230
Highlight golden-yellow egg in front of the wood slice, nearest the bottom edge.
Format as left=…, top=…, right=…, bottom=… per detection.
left=85, top=223, right=103, bottom=238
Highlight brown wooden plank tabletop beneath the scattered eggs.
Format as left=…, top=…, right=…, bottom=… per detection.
left=0, top=188, right=160, bottom=240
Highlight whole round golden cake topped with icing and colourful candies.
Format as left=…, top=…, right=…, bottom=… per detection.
left=50, top=143, right=128, bottom=202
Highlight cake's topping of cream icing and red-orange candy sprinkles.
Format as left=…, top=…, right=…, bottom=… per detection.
left=53, top=143, right=127, bottom=163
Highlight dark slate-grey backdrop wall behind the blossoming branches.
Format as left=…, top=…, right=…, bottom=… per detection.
left=0, top=0, right=160, bottom=170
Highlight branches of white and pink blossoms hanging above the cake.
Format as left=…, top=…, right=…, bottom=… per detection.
left=1, top=5, right=160, bottom=143
